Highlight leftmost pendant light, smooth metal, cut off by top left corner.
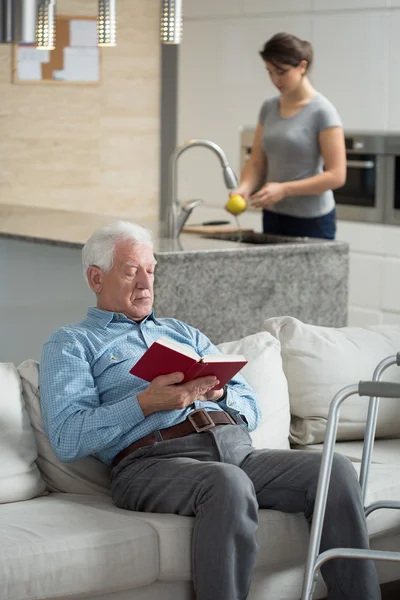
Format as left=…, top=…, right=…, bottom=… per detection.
left=0, top=0, right=37, bottom=44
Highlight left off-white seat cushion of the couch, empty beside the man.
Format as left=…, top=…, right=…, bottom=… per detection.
left=0, top=494, right=158, bottom=600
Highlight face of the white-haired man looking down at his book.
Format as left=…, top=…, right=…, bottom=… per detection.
left=88, top=242, right=156, bottom=321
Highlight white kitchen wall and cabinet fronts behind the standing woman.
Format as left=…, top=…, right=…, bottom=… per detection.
left=179, top=0, right=400, bottom=325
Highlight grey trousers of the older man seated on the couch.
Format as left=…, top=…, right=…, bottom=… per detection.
left=111, top=425, right=381, bottom=600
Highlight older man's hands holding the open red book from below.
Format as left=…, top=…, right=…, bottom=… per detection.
left=137, top=373, right=223, bottom=417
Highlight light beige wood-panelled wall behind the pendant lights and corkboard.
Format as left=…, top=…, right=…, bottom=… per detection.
left=0, top=0, right=160, bottom=217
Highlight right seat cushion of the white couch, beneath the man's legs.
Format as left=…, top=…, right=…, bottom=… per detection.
left=135, top=464, right=400, bottom=581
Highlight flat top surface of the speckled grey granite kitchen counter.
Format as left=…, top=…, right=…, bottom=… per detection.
left=0, top=204, right=347, bottom=254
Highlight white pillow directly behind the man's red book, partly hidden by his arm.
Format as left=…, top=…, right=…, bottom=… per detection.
left=218, top=331, right=290, bottom=449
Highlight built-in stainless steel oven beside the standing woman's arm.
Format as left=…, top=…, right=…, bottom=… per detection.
left=334, top=132, right=387, bottom=223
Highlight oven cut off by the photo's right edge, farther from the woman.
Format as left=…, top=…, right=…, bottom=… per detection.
left=385, top=133, right=400, bottom=225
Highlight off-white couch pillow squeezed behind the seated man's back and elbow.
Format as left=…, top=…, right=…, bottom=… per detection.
left=18, top=360, right=111, bottom=495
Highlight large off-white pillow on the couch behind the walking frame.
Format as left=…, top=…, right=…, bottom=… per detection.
left=265, top=317, right=400, bottom=445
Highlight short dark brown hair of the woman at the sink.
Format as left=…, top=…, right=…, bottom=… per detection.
left=260, top=33, right=313, bottom=70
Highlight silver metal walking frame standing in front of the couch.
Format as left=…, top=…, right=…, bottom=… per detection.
left=301, top=352, right=400, bottom=600
